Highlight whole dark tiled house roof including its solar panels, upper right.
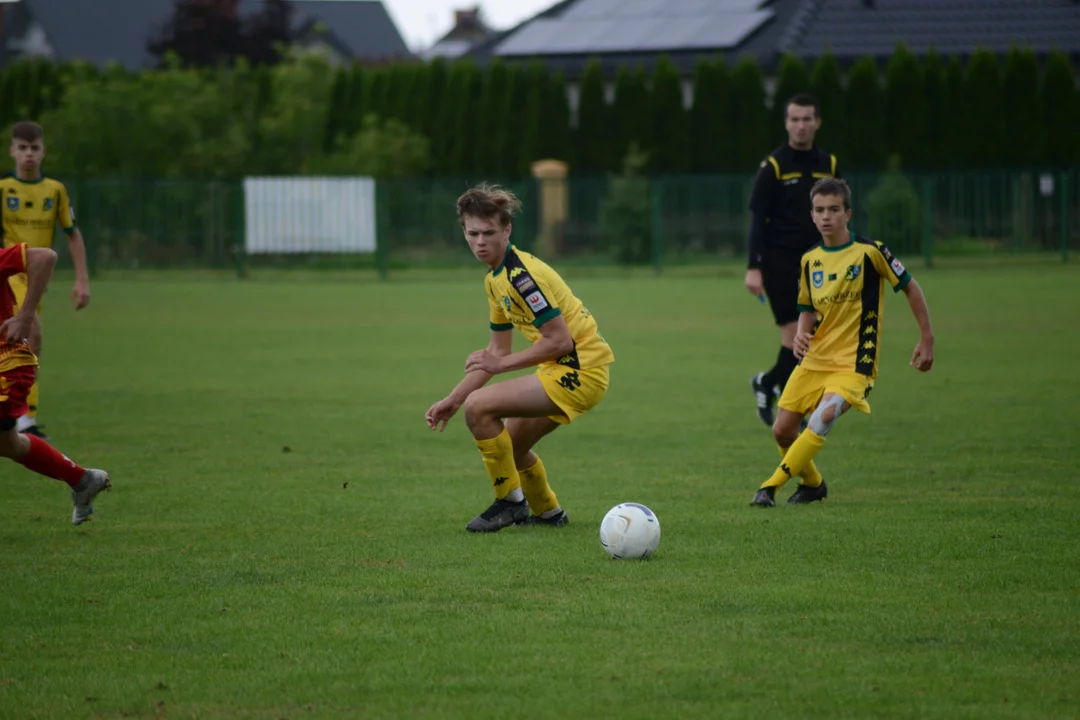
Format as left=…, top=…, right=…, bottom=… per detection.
left=470, top=0, right=1080, bottom=78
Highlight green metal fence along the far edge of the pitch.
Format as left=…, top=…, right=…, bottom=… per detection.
left=54, top=171, right=1080, bottom=276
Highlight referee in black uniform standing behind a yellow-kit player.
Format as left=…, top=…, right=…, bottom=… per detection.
left=746, top=94, right=840, bottom=427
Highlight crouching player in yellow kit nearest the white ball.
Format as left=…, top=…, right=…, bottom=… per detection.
left=427, top=185, right=615, bottom=532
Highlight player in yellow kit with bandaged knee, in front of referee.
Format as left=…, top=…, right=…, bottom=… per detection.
left=751, top=178, right=934, bottom=507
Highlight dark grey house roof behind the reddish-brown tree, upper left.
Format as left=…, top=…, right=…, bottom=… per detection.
left=9, top=0, right=409, bottom=69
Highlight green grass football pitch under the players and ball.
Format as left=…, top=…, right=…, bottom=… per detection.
left=0, top=262, right=1080, bottom=719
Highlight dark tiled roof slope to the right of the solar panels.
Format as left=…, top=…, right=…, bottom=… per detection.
left=778, top=0, right=1080, bottom=59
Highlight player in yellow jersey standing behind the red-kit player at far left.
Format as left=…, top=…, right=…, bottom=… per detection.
left=0, top=122, right=90, bottom=438
